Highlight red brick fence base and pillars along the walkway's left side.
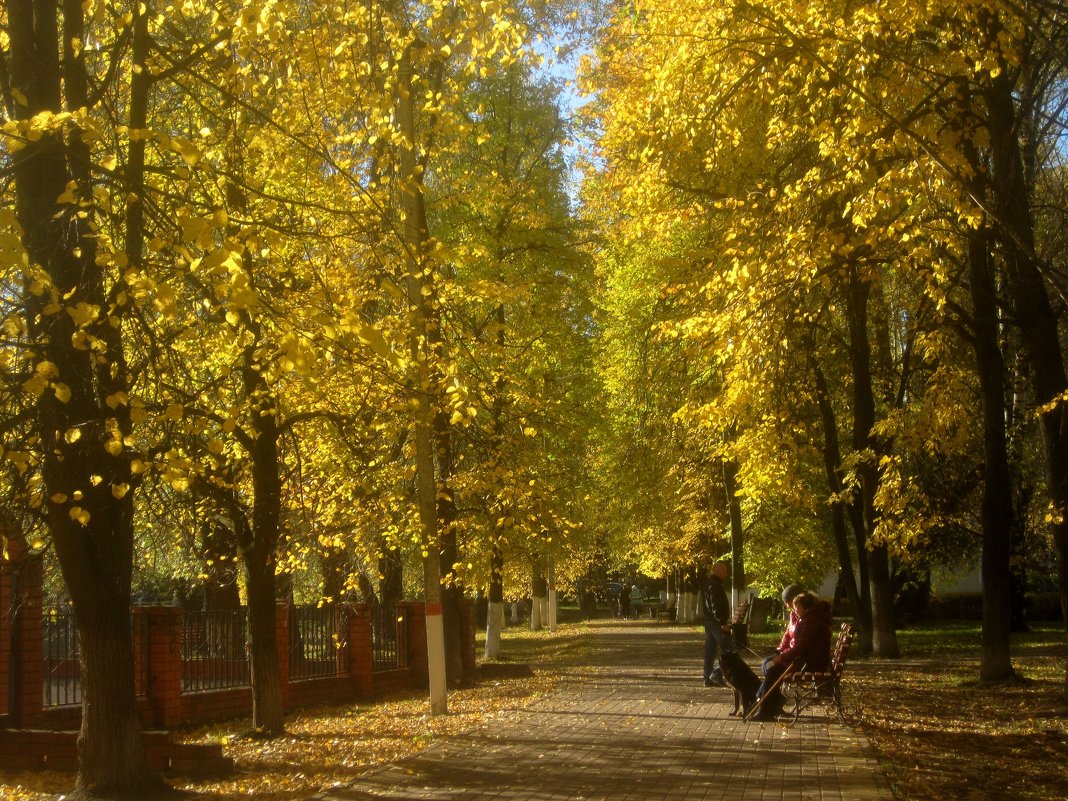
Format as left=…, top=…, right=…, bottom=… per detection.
left=0, top=540, right=475, bottom=771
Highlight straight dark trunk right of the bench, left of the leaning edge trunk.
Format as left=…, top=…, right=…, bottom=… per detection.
left=968, top=217, right=1014, bottom=681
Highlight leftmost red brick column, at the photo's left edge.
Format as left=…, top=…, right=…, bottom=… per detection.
left=10, top=539, right=45, bottom=728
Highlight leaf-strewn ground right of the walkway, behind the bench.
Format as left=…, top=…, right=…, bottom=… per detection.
left=844, top=629, right=1068, bottom=801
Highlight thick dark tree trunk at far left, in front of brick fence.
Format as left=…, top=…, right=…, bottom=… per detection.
left=4, top=0, right=156, bottom=795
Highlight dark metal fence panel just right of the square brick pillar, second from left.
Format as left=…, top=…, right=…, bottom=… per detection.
left=182, top=609, right=249, bottom=692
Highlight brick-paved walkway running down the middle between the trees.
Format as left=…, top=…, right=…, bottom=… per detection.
left=318, top=623, right=893, bottom=801
